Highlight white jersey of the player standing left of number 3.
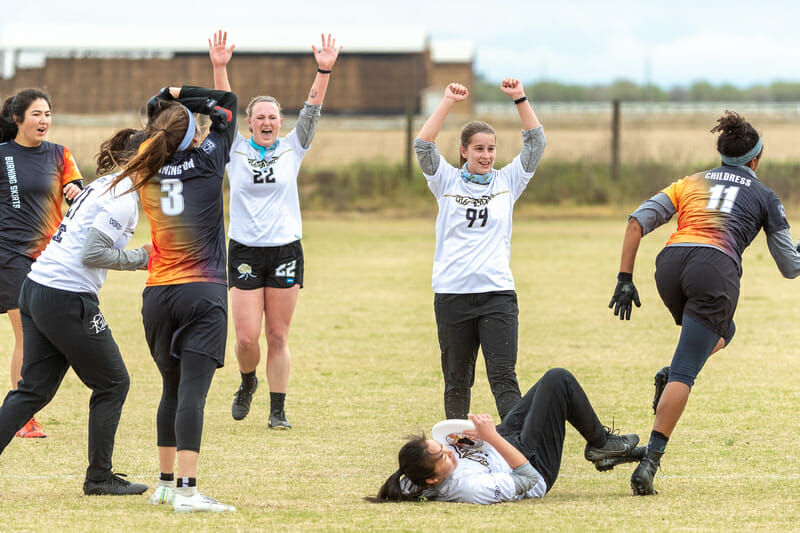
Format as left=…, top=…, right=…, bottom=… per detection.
left=28, top=174, right=139, bottom=294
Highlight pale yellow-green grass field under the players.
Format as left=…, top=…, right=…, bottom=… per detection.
left=0, top=213, right=800, bottom=531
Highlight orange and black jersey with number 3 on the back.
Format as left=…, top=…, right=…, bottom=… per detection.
left=141, top=87, right=236, bottom=286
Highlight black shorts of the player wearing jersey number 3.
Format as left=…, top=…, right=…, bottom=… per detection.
left=142, top=282, right=228, bottom=371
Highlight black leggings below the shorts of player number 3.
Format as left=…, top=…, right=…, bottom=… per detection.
left=156, top=352, right=217, bottom=453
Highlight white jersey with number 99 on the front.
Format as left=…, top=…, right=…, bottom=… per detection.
left=425, top=156, right=534, bottom=294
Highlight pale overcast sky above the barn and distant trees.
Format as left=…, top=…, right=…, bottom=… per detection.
left=0, top=0, right=800, bottom=88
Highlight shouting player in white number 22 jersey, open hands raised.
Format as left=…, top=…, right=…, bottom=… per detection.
left=208, top=31, right=342, bottom=429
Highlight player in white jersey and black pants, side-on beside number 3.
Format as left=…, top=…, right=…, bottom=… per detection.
left=0, top=130, right=151, bottom=495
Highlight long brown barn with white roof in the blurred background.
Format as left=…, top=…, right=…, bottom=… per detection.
left=0, top=27, right=474, bottom=115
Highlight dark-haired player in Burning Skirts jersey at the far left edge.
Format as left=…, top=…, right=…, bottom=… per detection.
left=0, top=89, right=82, bottom=437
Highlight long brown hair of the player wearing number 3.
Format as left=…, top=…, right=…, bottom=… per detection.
left=111, top=102, right=189, bottom=191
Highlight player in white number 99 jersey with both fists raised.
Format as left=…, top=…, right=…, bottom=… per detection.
left=414, top=78, right=545, bottom=418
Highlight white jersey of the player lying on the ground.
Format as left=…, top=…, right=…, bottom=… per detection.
left=422, top=432, right=547, bottom=504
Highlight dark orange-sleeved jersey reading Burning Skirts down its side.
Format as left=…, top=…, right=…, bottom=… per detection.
left=0, top=140, right=82, bottom=258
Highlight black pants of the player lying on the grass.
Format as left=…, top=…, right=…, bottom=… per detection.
left=497, top=368, right=607, bottom=491
